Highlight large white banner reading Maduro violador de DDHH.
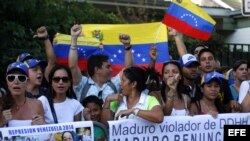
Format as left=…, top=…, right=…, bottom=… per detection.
left=109, top=113, right=250, bottom=141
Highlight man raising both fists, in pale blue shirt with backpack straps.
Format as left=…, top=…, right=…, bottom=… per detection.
left=69, top=25, right=133, bottom=101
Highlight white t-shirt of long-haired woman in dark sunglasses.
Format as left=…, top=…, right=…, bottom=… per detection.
left=38, top=96, right=83, bottom=124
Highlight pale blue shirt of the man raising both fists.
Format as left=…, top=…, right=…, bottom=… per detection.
left=73, top=73, right=121, bottom=101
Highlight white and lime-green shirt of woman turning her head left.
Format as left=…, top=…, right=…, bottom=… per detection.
left=115, top=93, right=160, bottom=119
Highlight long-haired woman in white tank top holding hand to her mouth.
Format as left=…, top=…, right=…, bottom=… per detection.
left=151, top=60, right=191, bottom=116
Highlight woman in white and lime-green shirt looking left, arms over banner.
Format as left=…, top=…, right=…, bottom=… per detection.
left=102, top=67, right=164, bottom=124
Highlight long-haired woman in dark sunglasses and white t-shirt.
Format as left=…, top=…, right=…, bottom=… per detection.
left=39, top=65, right=83, bottom=123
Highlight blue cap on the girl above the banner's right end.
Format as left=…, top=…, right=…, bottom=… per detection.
left=201, top=71, right=225, bottom=85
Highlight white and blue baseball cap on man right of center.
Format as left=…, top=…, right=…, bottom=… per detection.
left=179, top=54, right=199, bottom=67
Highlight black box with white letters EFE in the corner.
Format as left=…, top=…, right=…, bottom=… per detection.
left=224, top=125, right=250, bottom=141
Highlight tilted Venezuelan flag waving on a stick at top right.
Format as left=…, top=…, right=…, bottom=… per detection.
left=163, top=0, right=216, bottom=41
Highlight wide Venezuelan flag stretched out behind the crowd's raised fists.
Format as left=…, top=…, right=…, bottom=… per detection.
left=54, top=22, right=169, bottom=75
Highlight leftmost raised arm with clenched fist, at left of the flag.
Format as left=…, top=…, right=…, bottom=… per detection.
left=34, top=26, right=56, bottom=81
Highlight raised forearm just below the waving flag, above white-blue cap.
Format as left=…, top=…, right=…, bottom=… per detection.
left=168, top=27, right=187, bottom=56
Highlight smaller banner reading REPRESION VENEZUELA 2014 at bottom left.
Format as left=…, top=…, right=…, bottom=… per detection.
left=0, top=121, right=94, bottom=141
